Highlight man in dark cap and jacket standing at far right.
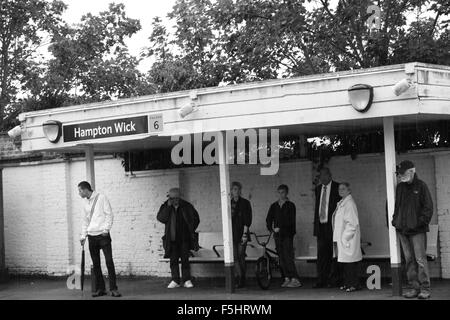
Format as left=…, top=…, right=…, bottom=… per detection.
left=392, top=160, right=433, bottom=299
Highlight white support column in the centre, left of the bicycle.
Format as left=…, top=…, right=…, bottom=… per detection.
left=217, top=132, right=234, bottom=293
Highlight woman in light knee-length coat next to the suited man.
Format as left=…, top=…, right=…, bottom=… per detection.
left=333, top=182, right=362, bottom=292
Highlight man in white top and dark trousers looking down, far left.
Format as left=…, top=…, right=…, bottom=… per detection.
left=78, top=181, right=121, bottom=298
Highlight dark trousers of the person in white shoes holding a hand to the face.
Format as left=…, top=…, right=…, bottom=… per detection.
left=170, top=241, right=191, bottom=284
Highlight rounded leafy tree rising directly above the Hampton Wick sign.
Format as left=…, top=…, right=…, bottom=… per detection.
left=22, top=4, right=154, bottom=115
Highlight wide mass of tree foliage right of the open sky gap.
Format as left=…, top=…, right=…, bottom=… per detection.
left=148, top=0, right=450, bottom=91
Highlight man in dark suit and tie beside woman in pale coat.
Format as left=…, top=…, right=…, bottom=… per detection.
left=314, top=167, right=341, bottom=288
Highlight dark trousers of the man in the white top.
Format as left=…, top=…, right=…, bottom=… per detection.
left=88, top=235, right=117, bottom=291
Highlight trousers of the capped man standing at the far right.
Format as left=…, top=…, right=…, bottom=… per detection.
left=398, top=233, right=430, bottom=292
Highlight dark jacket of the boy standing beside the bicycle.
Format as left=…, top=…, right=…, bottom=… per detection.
left=266, top=200, right=297, bottom=237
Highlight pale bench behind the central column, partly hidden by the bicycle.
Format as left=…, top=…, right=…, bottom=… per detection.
left=159, top=232, right=275, bottom=263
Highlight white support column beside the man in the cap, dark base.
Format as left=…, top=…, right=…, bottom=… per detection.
left=383, top=117, right=402, bottom=296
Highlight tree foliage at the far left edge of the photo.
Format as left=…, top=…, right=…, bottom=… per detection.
left=0, top=0, right=66, bottom=129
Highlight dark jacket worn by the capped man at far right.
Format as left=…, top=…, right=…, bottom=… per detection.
left=392, top=174, right=433, bottom=235
